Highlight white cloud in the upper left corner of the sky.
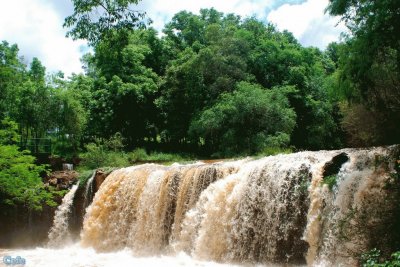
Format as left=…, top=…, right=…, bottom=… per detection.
left=0, top=0, right=85, bottom=75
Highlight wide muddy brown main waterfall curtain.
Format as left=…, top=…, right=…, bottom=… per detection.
left=79, top=146, right=400, bottom=266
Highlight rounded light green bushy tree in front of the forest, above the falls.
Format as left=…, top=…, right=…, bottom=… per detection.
left=190, top=82, right=296, bottom=156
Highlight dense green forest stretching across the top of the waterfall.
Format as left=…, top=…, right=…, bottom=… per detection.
left=0, top=0, right=400, bottom=214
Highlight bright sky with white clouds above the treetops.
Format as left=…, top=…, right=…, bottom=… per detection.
left=0, top=0, right=345, bottom=76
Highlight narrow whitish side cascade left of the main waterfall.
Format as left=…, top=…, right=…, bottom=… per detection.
left=48, top=182, right=79, bottom=247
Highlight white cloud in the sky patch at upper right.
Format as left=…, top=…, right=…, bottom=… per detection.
left=268, top=0, right=346, bottom=48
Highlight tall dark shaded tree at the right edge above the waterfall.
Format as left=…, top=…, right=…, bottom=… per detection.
left=328, top=0, right=400, bottom=145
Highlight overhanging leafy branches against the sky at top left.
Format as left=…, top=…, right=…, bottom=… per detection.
left=63, top=0, right=146, bottom=45
